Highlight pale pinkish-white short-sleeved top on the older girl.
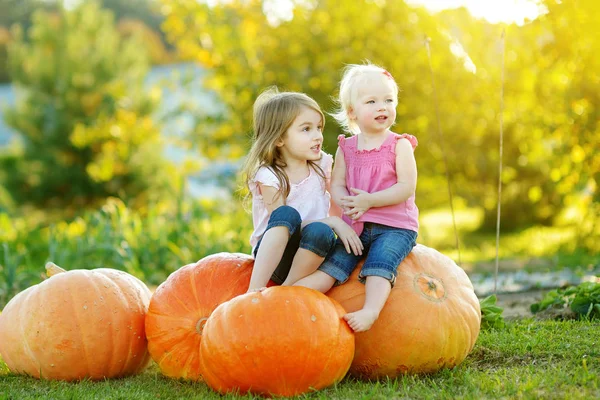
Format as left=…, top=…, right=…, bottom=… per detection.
left=249, top=152, right=333, bottom=252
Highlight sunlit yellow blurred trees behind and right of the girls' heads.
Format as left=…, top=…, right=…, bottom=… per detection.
left=162, top=0, right=600, bottom=230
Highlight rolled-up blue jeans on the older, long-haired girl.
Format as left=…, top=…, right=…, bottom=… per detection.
left=254, top=206, right=335, bottom=285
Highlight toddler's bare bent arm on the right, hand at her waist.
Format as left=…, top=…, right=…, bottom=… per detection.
left=342, top=139, right=417, bottom=219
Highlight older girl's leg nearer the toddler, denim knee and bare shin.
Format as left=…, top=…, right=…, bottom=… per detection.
left=282, top=222, right=335, bottom=286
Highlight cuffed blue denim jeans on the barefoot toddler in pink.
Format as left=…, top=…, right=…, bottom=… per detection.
left=319, top=222, right=417, bottom=286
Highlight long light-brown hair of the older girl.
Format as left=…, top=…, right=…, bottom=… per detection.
left=241, top=87, right=325, bottom=202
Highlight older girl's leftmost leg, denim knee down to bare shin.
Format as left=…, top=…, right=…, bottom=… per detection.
left=248, top=206, right=302, bottom=292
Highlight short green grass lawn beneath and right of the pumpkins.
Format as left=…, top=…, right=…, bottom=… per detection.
left=0, top=319, right=600, bottom=399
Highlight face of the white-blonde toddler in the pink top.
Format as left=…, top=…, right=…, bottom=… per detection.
left=348, top=72, right=398, bottom=134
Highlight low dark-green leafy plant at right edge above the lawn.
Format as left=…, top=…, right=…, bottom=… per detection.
left=531, top=282, right=600, bottom=319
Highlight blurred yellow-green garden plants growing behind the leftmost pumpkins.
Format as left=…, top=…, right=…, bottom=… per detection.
left=0, top=198, right=252, bottom=309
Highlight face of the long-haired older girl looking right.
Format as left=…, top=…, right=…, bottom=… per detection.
left=277, top=107, right=323, bottom=163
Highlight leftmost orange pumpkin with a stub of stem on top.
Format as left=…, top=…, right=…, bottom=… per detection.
left=0, top=263, right=151, bottom=381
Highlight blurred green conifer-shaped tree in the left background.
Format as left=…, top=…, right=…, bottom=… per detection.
left=3, top=2, right=171, bottom=207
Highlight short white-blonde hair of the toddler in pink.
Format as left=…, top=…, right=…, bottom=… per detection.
left=331, top=61, right=399, bottom=134
